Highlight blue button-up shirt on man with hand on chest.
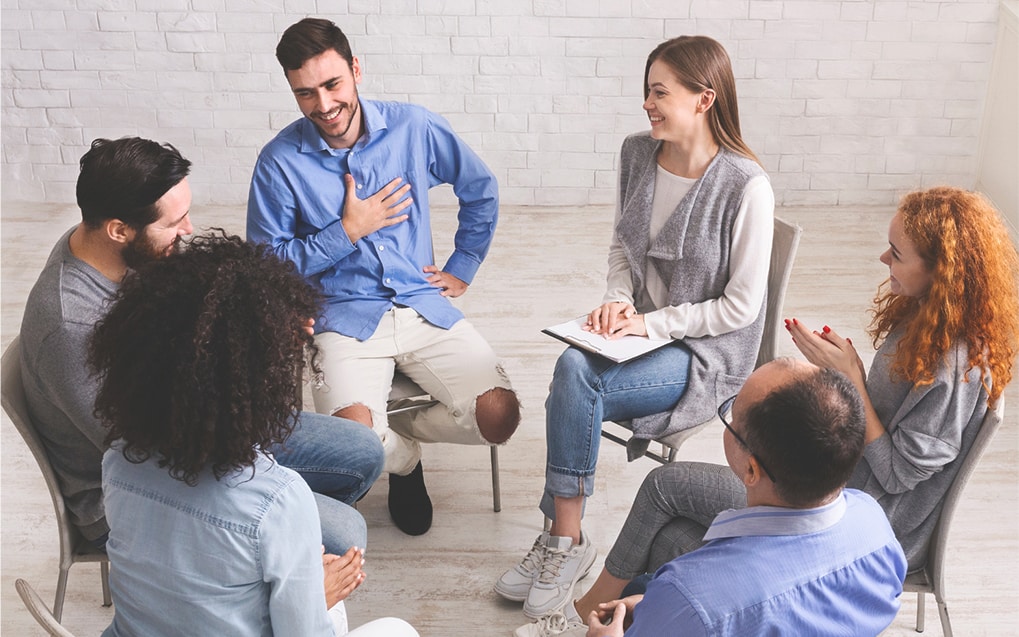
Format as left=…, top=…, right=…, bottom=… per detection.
left=248, top=99, right=498, bottom=340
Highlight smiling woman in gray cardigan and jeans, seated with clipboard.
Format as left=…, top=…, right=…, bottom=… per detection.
left=495, top=37, right=774, bottom=635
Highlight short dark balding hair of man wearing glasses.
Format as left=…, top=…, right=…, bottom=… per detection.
left=744, top=362, right=866, bottom=507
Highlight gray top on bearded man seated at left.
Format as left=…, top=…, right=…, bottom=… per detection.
left=21, top=228, right=117, bottom=540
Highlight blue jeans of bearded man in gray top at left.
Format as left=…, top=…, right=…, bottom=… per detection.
left=270, top=412, right=383, bottom=555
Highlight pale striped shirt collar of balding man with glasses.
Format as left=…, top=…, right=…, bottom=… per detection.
left=704, top=491, right=846, bottom=540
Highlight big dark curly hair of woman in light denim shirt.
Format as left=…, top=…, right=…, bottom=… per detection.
left=89, top=228, right=321, bottom=485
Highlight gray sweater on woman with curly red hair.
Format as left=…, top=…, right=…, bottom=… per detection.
left=848, top=332, right=987, bottom=571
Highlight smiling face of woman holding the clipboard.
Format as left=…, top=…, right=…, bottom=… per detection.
left=644, top=60, right=714, bottom=142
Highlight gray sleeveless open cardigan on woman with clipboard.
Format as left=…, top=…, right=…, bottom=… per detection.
left=615, top=132, right=766, bottom=460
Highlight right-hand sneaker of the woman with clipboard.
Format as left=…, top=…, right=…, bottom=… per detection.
left=524, top=532, right=598, bottom=619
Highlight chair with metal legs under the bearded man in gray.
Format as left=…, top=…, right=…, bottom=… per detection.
left=0, top=336, right=113, bottom=619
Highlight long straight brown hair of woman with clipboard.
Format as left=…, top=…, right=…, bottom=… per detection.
left=644, top=36, right=761, bottom=164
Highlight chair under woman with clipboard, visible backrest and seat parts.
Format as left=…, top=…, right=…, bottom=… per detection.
left=601, top=217, right=803, bottom=464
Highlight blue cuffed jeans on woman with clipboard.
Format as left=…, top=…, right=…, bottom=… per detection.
left=541, top=341, right=690, bottom=520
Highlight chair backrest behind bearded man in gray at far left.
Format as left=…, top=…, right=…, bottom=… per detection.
left=0, top=336, right=85, bottom=567
